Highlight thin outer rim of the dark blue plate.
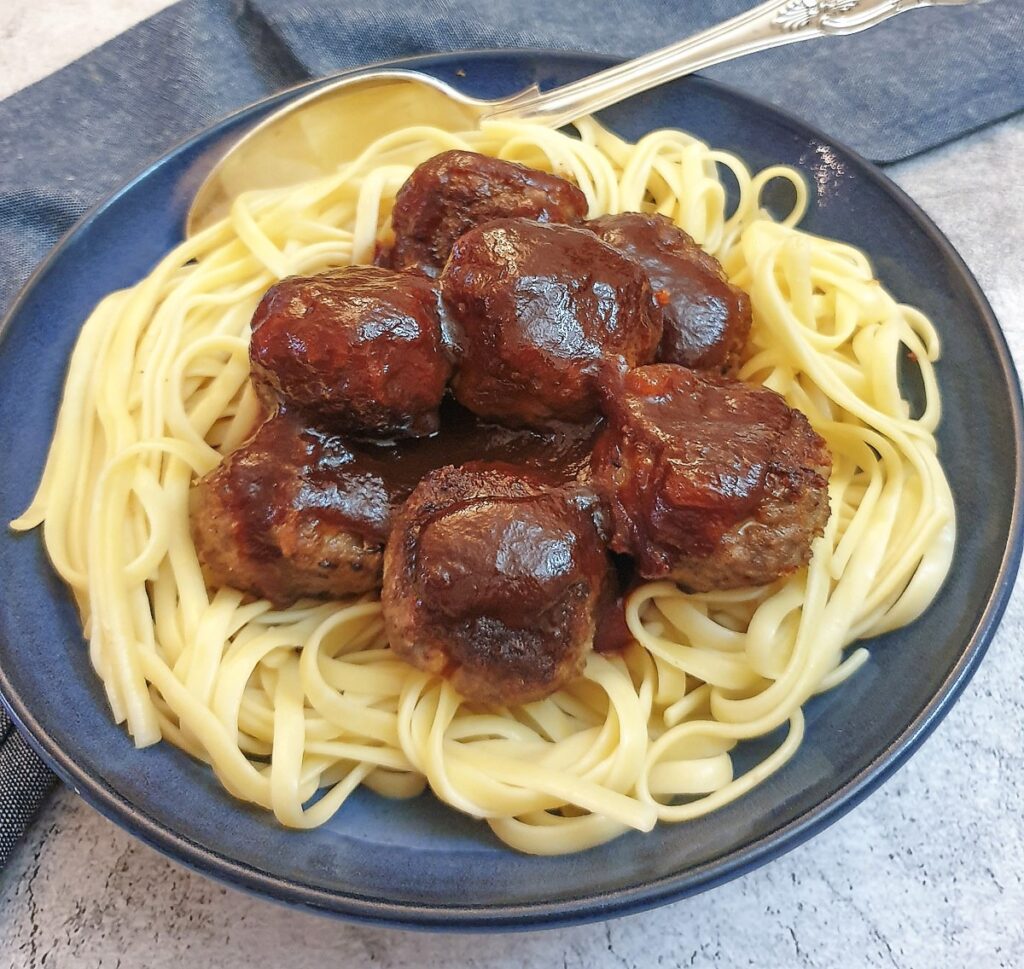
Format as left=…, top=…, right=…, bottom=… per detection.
left=0, top=47, right=1024, bottom=931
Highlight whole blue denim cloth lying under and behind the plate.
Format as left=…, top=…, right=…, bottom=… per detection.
left=0, top=0, right=1024, bottom=867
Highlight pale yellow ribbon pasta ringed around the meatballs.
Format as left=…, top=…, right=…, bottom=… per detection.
left=13, top=119, right=954, bottom=854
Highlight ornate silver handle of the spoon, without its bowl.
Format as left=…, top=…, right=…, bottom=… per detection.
left=482, top=0, right=975, bottom=128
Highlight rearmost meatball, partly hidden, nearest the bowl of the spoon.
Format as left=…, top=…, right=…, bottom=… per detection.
left=378, top=152, right=587, bottom=276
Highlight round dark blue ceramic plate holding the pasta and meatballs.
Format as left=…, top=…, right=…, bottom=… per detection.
left=0, top=52, right=1021, bottom=929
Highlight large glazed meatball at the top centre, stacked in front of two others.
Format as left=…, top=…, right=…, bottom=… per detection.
left=441, top=219, right=662, bottom=426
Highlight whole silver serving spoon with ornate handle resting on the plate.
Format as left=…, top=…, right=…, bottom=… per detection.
left=185, top=0, right=977, bottom=236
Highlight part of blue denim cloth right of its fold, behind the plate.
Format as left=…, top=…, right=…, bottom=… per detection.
left=249, top=0, right=1024, bottom=162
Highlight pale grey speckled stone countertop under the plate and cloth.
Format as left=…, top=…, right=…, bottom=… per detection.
left=0, top=0, right=1024, bottom=969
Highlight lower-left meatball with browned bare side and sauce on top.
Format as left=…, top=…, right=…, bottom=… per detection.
left=191, top=414, right=391, bottom=607
